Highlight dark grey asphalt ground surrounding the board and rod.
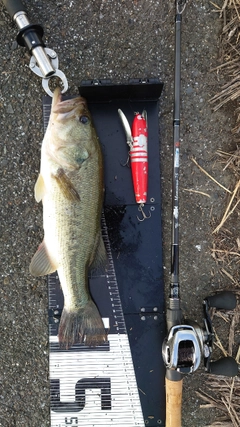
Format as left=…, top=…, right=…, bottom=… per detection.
left=0, top=0, right=234, bottom=427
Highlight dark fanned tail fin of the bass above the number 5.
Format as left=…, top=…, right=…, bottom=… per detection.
left=58, top=300, right=107, bottom=349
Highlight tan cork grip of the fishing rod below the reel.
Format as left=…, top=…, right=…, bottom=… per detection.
left=165, top=378, right=183, bottom=427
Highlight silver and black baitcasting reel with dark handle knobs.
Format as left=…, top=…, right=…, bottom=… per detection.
left=162, top=291, right=238, bottom=377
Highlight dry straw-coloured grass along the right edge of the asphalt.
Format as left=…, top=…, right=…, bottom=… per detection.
left=195, top=4, right=240, bottom=427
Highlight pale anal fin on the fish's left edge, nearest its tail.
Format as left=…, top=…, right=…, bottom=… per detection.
left=29, top=241, right=57, bottom=277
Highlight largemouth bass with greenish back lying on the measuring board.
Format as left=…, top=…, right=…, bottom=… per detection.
left=29, top=88, right=107, bottom=349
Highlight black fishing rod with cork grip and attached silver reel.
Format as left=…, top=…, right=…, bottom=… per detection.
left=162, top=0, right=238, bottom=427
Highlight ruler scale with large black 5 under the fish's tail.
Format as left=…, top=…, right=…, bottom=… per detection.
left=43, top=98, right=145, bottom=427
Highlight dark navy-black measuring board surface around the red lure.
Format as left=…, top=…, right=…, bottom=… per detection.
left=45, top=79, right=165, bottom=427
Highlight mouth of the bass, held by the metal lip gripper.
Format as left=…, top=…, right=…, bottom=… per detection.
left=51, top=87, right=87, bottom=118
